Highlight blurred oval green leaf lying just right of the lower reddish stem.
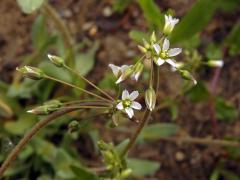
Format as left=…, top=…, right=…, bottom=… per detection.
left=142, top=123, right=180, bottom=140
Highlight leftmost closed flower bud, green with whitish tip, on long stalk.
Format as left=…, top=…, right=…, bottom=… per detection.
left=16, top=66, right=44, bottom=80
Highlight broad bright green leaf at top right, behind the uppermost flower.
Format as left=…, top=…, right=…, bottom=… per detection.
left=171, top=0, right=218, bottom=43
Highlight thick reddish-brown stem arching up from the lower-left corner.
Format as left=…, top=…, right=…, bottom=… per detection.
left=0, top=108, right=77, bottom=177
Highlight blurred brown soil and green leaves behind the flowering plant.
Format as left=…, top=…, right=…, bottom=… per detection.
left=0, top=0, right=240, bottom=180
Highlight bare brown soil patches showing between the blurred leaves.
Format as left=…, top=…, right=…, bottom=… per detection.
left=0, top=0, right=240, bottom=180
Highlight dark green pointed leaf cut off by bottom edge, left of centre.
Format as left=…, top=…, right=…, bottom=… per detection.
left=70, top=166, right=99, bottom=180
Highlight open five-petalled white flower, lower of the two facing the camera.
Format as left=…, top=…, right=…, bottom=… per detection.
left=116, top=90, right=142, bottom=118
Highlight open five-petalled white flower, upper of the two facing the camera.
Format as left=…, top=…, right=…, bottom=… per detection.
left=153, top=38, right=182, bottom=68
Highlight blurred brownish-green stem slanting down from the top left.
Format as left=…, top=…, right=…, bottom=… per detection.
left=43, top=3, right=75, bottom=67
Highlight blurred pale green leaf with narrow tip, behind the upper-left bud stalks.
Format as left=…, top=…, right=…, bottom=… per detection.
left=75, top=42, right=99, bottom=76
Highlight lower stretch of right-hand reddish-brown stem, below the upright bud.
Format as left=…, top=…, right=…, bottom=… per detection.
left=120, top=109, right=151, bottom=157
